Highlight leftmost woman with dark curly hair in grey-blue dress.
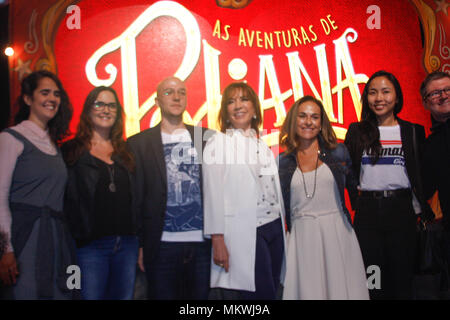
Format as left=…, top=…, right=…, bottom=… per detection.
left=0, top=71, right=75, bottom=299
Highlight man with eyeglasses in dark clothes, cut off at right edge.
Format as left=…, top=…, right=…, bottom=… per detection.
left=420, top=71, right=450, bottom=262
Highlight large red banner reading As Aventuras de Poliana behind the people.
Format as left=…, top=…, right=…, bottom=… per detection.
left=6, top=0, right=450, bottom=145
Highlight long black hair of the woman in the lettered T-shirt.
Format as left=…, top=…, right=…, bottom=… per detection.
left=359, top=70, right=403, bottom=164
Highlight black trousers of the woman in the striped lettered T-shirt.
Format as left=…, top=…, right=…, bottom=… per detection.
left=354, top=192, right=416, bottom=300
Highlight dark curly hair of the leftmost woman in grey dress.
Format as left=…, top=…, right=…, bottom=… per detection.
left=14, top=70, right=73, bottom=144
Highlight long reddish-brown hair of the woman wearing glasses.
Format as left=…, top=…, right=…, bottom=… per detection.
left=64, top=86, right=134, bottom=171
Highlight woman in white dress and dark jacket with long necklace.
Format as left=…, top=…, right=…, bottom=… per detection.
left=279, top=96, right=369, bottom=300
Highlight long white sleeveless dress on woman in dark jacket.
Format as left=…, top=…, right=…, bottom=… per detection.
left=283, top=164, right=369, bottom=300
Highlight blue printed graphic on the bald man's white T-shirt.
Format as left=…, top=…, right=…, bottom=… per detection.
left=164, top=142, right=203, bottom=232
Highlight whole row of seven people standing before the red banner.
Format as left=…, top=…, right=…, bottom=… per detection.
left=0, top=71, right=450, bottom=300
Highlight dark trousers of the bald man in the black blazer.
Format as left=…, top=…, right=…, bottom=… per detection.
left=145, top=240, right=211, bottom=300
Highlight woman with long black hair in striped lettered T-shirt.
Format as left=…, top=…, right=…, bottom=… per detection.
left=345, top=71, right=430, bottom=299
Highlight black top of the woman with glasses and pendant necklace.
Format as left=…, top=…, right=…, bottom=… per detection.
left=93, top=157, right=133, bottom=239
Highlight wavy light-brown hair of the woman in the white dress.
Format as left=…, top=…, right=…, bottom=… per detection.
left=279, top=95, right=337, bottom=153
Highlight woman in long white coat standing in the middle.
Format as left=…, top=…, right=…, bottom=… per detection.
left=203, top=83, right=285, bottom=299
